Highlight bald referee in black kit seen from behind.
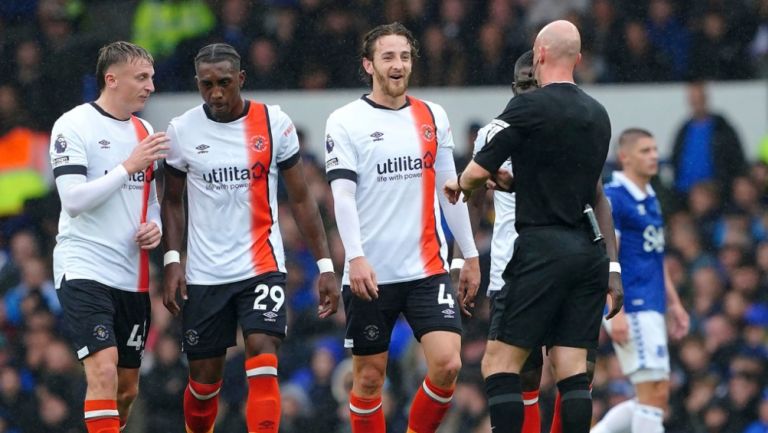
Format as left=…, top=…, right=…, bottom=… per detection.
left=444, top=21, right=623, bottom=433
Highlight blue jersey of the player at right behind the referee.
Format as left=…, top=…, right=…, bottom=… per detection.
left=605, top=171, right=666, bottom=314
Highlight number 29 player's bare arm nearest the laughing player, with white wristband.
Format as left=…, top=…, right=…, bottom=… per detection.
left=281, top=160, right=339, bottom=318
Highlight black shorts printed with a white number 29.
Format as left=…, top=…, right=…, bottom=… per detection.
left=181, top=272, right=287, bottom=360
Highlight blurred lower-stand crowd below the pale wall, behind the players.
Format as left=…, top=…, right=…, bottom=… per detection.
left=0, top=77, right=768, bottom=433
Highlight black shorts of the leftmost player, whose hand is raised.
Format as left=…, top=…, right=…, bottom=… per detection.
left=56, top=278, right=151, bottom=368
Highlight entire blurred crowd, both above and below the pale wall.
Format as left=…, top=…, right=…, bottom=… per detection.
left=0, top=0, right=768, bottom=433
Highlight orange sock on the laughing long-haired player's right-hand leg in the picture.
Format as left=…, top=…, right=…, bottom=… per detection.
left=408, top=377, right=453, bottom=433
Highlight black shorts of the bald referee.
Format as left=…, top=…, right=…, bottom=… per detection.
left=488, top=227, right=608, bottom=349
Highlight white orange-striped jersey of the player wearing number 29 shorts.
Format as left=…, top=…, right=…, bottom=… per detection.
left=166, top=101, right=300, bottom=285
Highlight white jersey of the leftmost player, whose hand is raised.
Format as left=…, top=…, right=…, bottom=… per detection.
left=50, top=103, right=157, bottom=291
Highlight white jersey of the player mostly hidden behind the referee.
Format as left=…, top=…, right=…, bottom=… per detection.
left=473, top=120, right=517, bottom=292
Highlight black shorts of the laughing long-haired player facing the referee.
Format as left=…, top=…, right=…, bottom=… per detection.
left=342, top=274, right=461, bottom=356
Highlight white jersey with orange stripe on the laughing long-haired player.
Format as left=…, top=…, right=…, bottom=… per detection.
left=325, top=96, right=453, bottom=284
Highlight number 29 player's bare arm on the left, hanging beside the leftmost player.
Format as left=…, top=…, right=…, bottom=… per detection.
left=160, top=166, right=187, bottom=316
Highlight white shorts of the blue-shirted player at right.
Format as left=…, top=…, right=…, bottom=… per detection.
left=603, top=311, right=669, bottom=383
